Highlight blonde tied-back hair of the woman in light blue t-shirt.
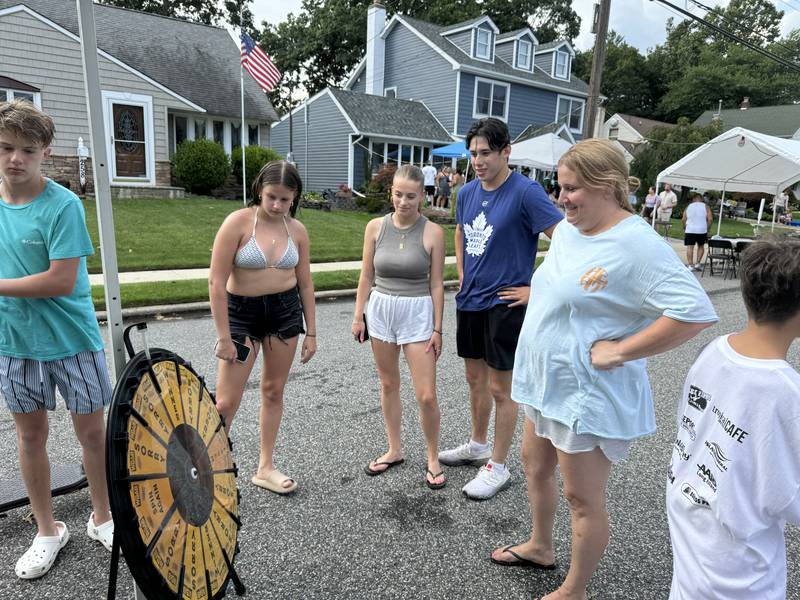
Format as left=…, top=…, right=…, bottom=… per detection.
left=558, top=139, right=638, bottom=213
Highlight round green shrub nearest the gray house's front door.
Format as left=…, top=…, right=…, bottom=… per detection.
left=172, top=140, right=231, bottom=194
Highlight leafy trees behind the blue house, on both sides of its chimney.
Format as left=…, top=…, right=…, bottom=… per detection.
left=261, top=0, right=580, bottom=111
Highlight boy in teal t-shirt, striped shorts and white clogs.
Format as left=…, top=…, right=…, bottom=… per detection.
left=0, top=100, right=114, bottom=579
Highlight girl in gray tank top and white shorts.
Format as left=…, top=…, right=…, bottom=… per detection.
left=351, top=165, right=446, bottom=489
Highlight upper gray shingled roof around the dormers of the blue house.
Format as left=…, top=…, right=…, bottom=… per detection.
left=401, top=16, right=589, bottom=96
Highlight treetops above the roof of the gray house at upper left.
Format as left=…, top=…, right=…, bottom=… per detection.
left=98, top=0, right=253, bottom=30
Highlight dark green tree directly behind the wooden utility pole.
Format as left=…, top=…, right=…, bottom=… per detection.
left=573, top=31, right=655, bottom=116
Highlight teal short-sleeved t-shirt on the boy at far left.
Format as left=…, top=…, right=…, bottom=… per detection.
left=0, top=180, right=103, bottom=360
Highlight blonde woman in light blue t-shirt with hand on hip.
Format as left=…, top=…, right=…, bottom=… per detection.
left=492, top=140, right=717, bottom=600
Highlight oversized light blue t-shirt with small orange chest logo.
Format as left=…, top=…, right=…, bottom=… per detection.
left=511, top=216, right=717, bottom=440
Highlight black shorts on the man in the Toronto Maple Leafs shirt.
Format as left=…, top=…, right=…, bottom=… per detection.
left=456, top=304, right=525, bottom=371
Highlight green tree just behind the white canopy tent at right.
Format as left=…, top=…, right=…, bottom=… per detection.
left=631, top=118, right=722, bottom=188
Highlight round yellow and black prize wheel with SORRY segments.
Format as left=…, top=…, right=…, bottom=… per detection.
left=107, top=324, right=244, bottom=600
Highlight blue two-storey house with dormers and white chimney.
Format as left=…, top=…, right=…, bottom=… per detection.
left=272, top=0, right=588, bottom=190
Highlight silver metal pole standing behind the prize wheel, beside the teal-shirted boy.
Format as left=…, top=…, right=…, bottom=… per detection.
left=76, top=0, right=125, bottom=376
